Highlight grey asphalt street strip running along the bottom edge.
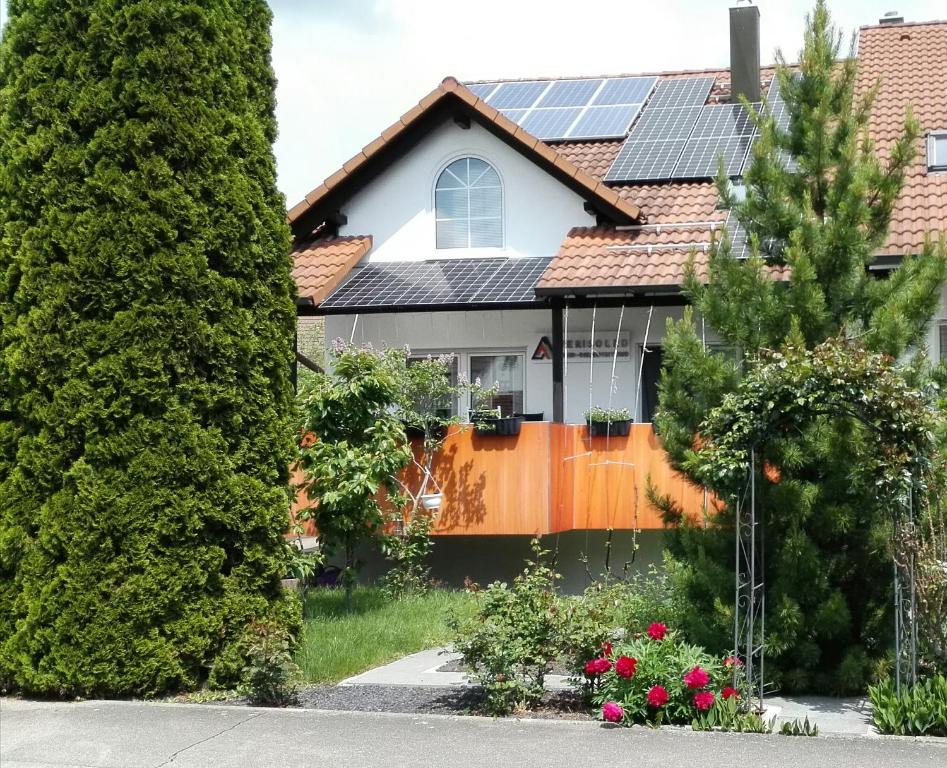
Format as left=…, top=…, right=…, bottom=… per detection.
left=0, top=699, right=947, bottom=768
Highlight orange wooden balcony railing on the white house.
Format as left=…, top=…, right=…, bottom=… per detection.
left=292, top=422, right=706, bottom=536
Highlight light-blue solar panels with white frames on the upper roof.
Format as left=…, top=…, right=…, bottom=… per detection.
left=467, top=77, right=657, bottom=141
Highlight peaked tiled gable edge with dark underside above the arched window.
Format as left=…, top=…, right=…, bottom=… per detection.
left=288, top=77, right=641, bottom=236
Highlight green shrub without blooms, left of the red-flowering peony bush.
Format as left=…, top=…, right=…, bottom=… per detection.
left=453, top=540, right=559, bottom=715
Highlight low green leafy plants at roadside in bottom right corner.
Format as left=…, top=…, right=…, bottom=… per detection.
left=868, top=675, right=947, bottom=736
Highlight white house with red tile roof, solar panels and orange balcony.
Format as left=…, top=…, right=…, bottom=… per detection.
left=289, top=5, right=947, bottom=576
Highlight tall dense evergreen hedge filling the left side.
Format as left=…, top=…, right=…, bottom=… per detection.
left=0, top=0, right=294, bottom=695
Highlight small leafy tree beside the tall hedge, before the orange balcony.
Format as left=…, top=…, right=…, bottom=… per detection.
left=299, top=345, right=411, bottom=609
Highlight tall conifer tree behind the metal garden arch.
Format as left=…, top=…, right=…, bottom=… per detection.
left=655, top=0, right=947, bottom=691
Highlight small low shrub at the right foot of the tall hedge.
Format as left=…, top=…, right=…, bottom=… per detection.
left=239, top=621, right=302, bottom=707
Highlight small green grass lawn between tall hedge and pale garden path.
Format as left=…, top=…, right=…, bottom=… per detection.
left=296, top=588, right=473, bottom=683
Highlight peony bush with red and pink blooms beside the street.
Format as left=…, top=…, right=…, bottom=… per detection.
left=585, top=622, right=739, bottom=725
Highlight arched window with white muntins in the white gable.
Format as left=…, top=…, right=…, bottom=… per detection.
left=434, top=157, right=503, bottom=248
